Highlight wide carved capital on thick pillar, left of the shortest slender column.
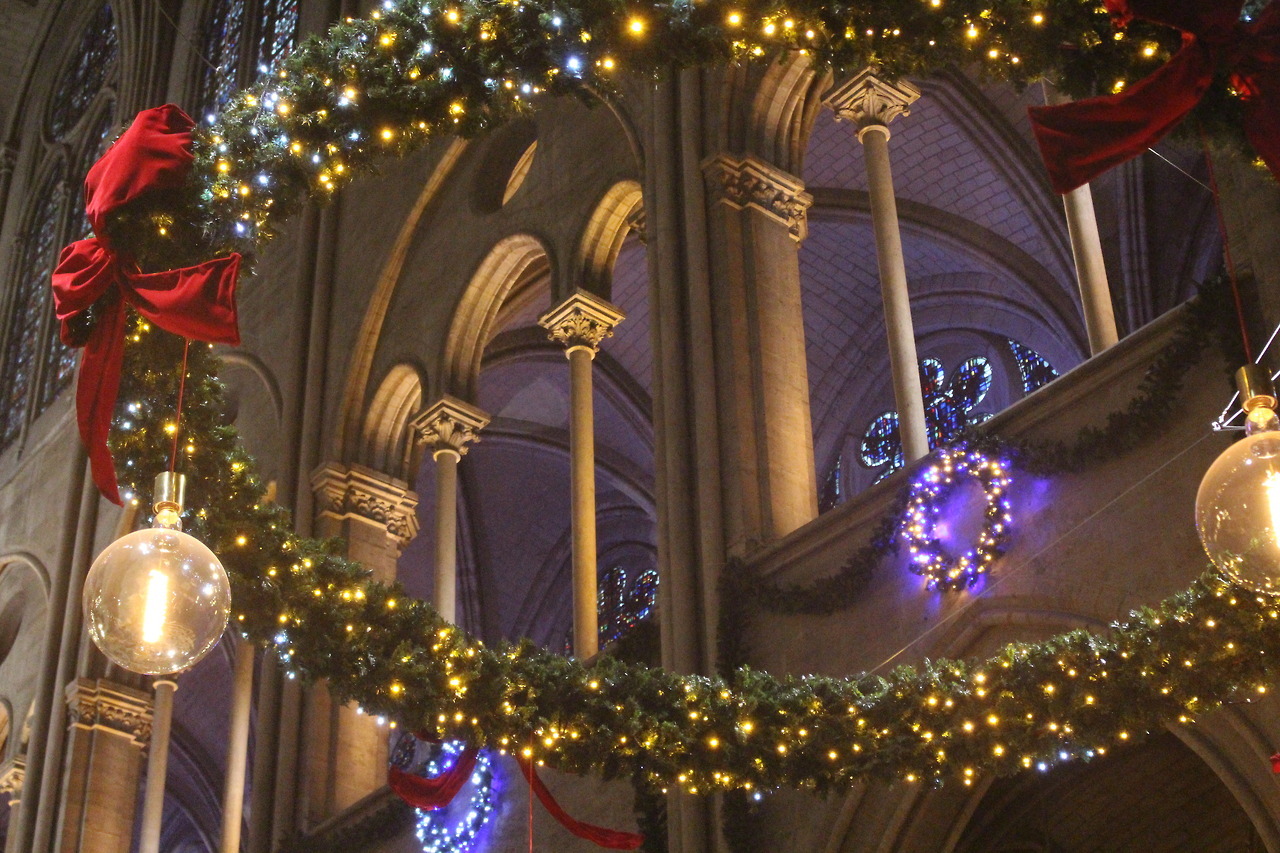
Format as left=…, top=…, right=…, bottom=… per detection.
left=311, top=462, right=417, bottom=548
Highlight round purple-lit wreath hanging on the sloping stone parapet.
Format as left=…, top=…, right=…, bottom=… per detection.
left=901, top=444, right=1012, bottom=589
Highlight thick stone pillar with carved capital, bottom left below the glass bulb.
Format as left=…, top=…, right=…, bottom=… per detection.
left=54, top=679, right=151, bottom=853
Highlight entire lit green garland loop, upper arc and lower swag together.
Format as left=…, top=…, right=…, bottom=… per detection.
left=90, top=0, right=1280, bottom=793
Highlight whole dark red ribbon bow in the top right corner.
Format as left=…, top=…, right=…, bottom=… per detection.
left=1029, top=0, right=1280, bottom=193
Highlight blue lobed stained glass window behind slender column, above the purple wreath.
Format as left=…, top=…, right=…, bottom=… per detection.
left=859, top=356, right=995, bottom=483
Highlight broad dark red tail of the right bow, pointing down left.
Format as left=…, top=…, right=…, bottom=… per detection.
left=1028, top=41, right=1213, bottom=195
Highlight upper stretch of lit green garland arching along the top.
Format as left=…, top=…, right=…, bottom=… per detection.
left=110, top=0, right=1243, bottom=269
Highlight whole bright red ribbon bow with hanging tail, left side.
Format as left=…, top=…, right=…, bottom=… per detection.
left=54, top=104, right=241, bottom=503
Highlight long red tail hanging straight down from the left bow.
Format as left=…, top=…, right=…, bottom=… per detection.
left=76, top=300, right=124, bottom=505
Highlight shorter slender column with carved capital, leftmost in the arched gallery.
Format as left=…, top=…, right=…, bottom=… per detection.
left=413, top=396, right=489, bottom=622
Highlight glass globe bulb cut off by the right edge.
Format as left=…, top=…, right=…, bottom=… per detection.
left=1196, top=366, right=1280, bottom=594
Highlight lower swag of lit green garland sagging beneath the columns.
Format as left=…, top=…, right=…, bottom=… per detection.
left=102, top=307, right=1280, bottom=793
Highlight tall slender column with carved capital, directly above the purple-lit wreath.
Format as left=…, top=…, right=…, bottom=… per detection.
left=824, top=68, right=929, bottom=462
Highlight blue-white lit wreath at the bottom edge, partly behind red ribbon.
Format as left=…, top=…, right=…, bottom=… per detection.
left=390, top=733, right=497, bottom=853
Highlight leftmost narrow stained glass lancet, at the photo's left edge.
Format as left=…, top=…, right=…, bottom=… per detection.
left=0, top=170, right=63, bottom=446
